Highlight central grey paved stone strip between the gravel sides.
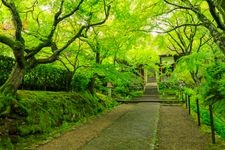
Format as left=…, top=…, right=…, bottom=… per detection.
left=80, top=103, right=159, bottom=150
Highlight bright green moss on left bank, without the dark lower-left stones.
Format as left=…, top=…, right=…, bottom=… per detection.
left=0, top=91, right=117, bottom=147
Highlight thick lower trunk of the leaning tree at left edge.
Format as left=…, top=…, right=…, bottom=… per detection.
left=0, top=65, right=25, bottom=96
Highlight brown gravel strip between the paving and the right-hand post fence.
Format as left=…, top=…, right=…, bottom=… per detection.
left=158, top=105, right=211, bottom=150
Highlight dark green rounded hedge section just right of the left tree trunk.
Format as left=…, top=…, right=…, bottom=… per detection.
left=22, top=65, right=72, bottom=91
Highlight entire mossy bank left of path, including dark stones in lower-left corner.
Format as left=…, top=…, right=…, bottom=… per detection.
left=0, top=91, right=117, bottom=149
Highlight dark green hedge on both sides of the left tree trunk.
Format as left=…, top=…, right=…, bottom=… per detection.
left=0, top=56, right=72, bottom=91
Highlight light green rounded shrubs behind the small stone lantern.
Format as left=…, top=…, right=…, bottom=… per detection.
left=71, top=65, right=143, bottom=97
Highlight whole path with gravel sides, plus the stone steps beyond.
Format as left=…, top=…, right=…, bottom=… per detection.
left=38, top=79, right=221, bottom=150
